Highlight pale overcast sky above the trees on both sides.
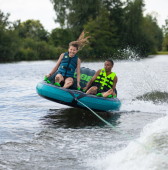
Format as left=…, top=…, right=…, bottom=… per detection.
left=0, top=0, right=168, bottom=32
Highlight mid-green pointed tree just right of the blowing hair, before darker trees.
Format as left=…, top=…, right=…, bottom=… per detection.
left=84, top=8, right=118, bottom=57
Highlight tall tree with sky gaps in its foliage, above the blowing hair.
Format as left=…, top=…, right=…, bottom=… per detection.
left=50, top=0, right=101, bottom=39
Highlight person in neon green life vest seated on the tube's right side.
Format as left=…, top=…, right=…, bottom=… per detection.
left=83, top=60, right=118, bottom=97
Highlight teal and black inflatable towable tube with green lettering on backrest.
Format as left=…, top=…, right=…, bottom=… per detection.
left=36, top=67, right=121, bottom=111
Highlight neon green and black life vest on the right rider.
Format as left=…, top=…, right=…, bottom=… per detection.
left=94, top=68, right=116, bottom=91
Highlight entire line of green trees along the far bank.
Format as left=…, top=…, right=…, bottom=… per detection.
left=0, top=0, right=168, bottom=62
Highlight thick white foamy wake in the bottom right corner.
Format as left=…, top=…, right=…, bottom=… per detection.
left=88, top=115, right=168, bottom=170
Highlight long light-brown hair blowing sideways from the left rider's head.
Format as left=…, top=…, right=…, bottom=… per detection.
left=69, top=30, right=91, bottom=51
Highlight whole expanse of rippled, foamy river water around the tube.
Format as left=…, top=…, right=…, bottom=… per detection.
left=0, top=55, right=168, bottom=170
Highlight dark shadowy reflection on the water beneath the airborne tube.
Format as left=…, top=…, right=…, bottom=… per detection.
left=40, top=108, right=120, bottom=128
